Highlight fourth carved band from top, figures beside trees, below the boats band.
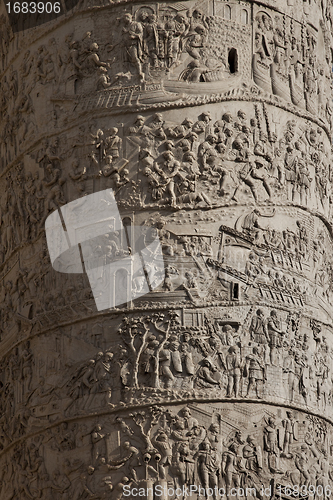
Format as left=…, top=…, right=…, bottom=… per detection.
left=0, top=307, right=333, bottom=449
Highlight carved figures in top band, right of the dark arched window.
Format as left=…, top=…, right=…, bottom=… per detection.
left=253, top=11, right=332, bottom=122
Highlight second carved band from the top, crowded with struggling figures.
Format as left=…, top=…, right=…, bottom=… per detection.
left=1, top=106, right=332, bottom=270
